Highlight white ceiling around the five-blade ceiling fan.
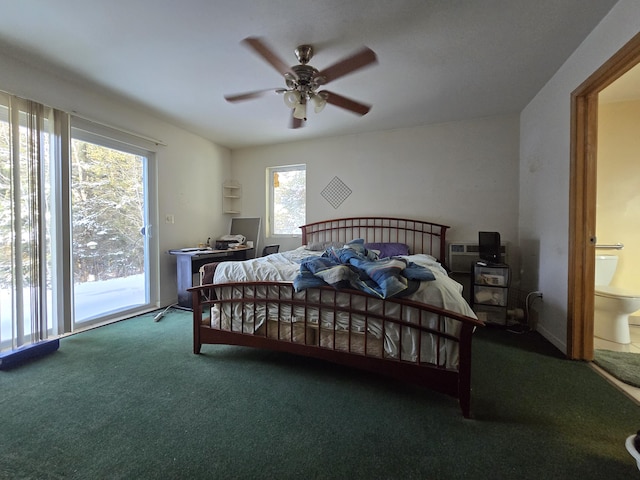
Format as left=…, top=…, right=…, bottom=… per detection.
left=0, top=0, right=616, bottom=148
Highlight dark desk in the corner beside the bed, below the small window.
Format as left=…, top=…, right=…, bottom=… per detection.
left=169, top=247, right=253, bottom=308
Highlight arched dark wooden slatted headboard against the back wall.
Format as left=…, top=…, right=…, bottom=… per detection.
left=300, top=217, right=450, bottom=265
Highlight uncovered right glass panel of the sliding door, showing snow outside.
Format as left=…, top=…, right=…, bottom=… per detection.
left=71, top=129, right=150, bottom=329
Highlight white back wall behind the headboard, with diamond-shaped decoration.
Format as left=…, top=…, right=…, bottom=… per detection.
left=231, top=115, right=519, bottom=266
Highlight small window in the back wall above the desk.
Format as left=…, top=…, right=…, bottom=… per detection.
left=267, top=165, right=307, bottom=237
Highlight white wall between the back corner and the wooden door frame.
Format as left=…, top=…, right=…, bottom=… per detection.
left=519, top=0, right=640, bottom=352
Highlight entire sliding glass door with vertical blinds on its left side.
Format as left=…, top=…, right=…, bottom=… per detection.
left=0, top=92, right=159, bottom=352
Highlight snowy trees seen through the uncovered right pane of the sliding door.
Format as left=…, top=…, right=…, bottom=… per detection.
left=71, top=140, right=145, bottom=283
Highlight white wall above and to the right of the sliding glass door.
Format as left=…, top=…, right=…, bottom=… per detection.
left=0, top=48, right=231, bottom=305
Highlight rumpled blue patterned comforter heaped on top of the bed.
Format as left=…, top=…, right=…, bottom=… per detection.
left=293, top=239, right=435, bottom=298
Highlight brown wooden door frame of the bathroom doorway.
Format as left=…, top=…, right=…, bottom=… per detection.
left=567, top=33, right=640, bottom=360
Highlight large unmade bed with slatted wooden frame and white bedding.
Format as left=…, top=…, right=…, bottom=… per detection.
left=189, top=217, right=484, bottom=418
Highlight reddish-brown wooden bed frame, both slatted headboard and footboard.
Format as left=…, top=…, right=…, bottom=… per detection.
left=189, top=217, right=484, bottom=418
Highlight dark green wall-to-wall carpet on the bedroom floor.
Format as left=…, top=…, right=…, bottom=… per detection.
left=0, top=311, right=640, bottom=480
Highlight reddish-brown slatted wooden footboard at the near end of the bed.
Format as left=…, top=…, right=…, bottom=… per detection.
left=189, top=282, right=483, bottom=417
